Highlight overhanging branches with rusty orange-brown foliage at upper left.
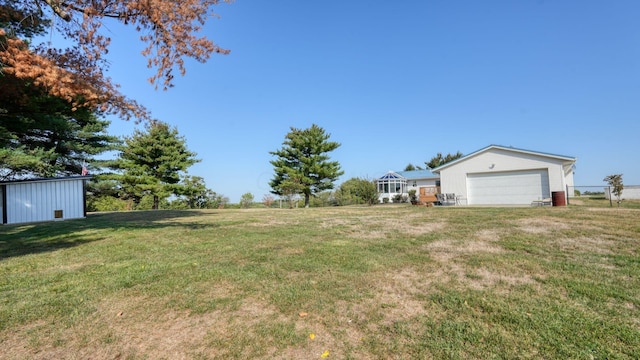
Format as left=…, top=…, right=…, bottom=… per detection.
left=0, top=0, right=230, bottom=119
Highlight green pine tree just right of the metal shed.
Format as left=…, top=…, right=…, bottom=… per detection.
left=114, top=121, right=200, bottom=209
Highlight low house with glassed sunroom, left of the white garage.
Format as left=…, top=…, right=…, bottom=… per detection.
left=376, top=170, right=440, bottom=202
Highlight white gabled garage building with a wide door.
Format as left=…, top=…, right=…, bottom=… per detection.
left=432, top=145, right=576, bottom=205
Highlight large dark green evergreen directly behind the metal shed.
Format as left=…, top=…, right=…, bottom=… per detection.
left=0, top=75, right=120, bottom=179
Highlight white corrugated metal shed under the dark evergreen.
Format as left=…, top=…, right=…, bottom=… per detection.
left=0, top=176, right=91, bottom=224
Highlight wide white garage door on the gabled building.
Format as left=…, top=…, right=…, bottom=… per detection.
left=467, top=169, right=551, bottom=205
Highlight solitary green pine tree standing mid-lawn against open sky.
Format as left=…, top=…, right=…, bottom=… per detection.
left=269, top=124, right=343, bottom=207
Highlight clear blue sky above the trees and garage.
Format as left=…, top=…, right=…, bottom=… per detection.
left=94, top=0, right=640, bottom=202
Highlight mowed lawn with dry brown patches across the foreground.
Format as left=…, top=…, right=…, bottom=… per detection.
left=0, top=205, right=640, bottom=359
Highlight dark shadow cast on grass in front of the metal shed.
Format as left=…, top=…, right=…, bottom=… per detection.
left=0, top=210, right=217, bottom=260
